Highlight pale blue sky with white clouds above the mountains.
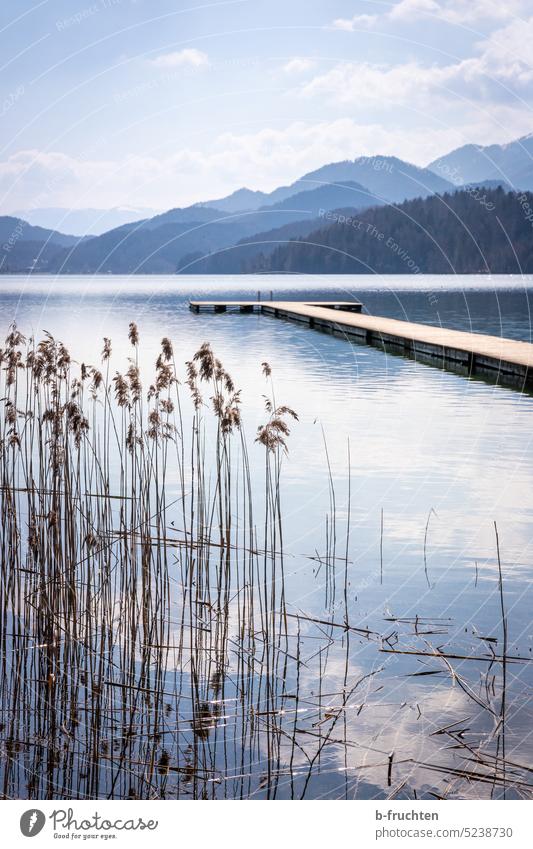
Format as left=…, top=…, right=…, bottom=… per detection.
left=0, top=0, right=533, bottom=214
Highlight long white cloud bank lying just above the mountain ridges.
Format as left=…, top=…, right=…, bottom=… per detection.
left=0, top=118, right=470, bottom=214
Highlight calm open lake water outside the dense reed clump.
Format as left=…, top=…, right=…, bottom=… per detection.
left=0, top=276, right=533, bottom=798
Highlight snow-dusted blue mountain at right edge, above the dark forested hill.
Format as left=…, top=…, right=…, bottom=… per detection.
left=428, top=134, right=533, bottom=189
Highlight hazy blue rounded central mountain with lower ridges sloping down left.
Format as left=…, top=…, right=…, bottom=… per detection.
left=2, top=152, right=453, bottom=274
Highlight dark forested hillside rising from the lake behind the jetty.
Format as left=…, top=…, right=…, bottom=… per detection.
left=258, top=187, right=533, bottom=274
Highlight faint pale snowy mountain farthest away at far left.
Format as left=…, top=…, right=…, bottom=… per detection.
left=11, top=207, right=157, bottom=236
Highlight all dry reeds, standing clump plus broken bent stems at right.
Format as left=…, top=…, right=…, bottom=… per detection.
left=0, top=323, right=529, bottom=799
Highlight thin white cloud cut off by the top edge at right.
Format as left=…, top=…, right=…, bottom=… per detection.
left=333, top=0, right=528, bottom=32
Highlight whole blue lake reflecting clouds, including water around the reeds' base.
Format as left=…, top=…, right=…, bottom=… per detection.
left=0, top=275, right=533, bottom=799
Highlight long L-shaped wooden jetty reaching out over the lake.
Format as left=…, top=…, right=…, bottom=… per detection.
left=189, top=301, right=533, bottom=389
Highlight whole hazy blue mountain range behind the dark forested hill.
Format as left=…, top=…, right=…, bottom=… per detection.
left=0, top=135, right=533, bottom=274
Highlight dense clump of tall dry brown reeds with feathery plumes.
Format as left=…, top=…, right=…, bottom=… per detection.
left=0, top=323, right=296, bottom=798
